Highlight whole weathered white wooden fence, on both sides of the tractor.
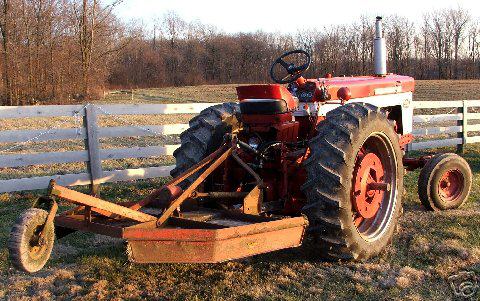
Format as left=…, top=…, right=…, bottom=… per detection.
left=0, top=100, right=480, bottom=193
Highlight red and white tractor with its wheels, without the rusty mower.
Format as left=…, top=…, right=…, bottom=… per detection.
left=171, top=19, right=471, bottom=259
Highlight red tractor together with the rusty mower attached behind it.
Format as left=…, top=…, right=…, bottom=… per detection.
left=9, top=18, right=472, bottom=272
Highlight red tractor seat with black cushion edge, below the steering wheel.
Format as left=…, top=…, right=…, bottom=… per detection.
left=237, top=85, right=298, bottom=115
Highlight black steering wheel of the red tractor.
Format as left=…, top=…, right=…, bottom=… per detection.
left=270, top=49, right=312, bottom=84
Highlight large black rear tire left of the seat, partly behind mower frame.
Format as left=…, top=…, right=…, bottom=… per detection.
left=170, top=103, right=240, bottom=187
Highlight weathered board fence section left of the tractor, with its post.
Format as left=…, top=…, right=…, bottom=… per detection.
left=0, top=103, right=221, bottom=193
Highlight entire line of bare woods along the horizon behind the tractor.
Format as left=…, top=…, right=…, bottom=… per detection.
left=0, top=0, right=480, bottom=105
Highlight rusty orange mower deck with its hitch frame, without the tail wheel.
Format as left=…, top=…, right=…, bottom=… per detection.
left=44, top=144, right=308, bottom=263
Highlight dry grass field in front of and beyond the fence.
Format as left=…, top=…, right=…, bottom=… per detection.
left=0, top=81, right=480, bottom=300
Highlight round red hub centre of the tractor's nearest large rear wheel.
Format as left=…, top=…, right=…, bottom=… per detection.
left=353, top=153, right=390, bottom=219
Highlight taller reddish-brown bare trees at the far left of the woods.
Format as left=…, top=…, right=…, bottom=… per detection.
left=0, top=0, right=126, bottom=105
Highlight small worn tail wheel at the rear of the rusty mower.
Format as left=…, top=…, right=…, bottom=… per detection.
left=8, top=208, right=55, bottom=273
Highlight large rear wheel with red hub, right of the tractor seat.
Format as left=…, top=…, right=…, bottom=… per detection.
left=302, top=103, right=404, bottom=260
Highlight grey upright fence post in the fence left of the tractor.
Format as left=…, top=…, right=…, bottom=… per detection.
left=83, top=104, right=103, bottom=196
